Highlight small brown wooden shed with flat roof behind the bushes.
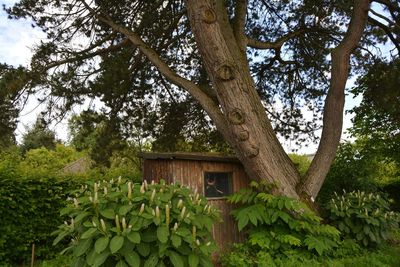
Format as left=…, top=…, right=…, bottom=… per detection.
left=140, top=153, right=250, bottom=248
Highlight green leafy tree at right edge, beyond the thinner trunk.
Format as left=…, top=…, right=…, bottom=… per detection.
left=351, top=58, right=400, bottom=166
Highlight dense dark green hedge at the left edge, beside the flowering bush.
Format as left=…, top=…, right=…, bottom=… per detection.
left=0, top=177, right=81, bottom=266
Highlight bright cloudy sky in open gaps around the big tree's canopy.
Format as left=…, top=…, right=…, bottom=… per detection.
left=0, top=0, right=360, bottom=154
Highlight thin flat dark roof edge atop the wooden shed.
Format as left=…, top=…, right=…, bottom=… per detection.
left=139, top=152, right=240, bottom=163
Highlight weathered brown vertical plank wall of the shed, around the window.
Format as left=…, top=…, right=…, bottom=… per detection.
left=143, top=159, right=250, bottom=249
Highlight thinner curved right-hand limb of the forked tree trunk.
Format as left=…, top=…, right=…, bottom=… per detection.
left=297, top=0, right=370, bottom=199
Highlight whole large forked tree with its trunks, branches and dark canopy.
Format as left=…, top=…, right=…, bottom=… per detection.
left=3, top=0, right=400, bottom=199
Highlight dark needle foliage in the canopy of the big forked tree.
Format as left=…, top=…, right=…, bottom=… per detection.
left=6, top=0, right=386, bottom=148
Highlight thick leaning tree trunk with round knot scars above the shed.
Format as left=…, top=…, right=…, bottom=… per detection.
left=187, top=0, right=300, bottom=198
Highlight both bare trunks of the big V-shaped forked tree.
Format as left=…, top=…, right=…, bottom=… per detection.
left=187, top=0, right=370, bottom=200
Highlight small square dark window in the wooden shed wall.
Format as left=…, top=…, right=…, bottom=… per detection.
left=204, top=172, right=232, bottom=197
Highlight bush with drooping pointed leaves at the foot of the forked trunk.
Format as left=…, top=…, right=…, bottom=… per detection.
left=222, top=182, right=340, bottom=266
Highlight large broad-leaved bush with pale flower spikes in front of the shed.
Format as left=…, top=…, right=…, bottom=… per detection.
left=54, top=179, right=218, bottom=267
